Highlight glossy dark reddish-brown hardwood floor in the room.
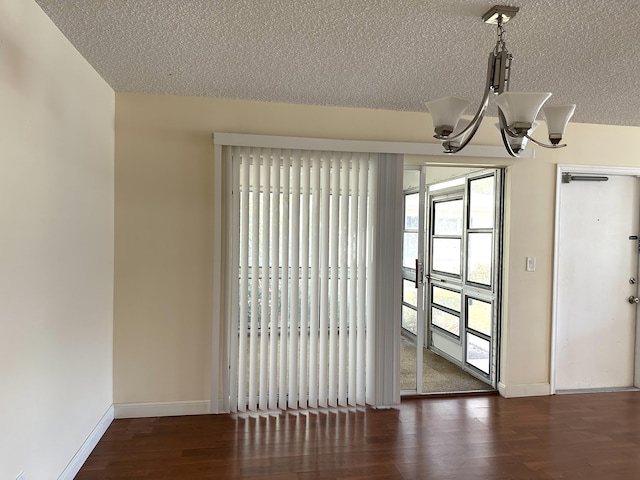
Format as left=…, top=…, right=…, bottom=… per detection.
left=76, top=392, right=640, bottom=480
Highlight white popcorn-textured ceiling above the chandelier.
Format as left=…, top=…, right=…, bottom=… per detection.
left=36, top=0, right=640, bottom=126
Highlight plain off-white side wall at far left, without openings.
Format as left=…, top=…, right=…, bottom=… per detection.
left=0, top=0, right=114, bottom=480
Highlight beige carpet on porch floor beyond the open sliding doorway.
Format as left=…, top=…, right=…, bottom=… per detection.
left=400, top=335, right=493, bottom=393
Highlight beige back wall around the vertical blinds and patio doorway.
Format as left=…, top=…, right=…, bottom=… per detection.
left=114, top=93, right=640, bottom=403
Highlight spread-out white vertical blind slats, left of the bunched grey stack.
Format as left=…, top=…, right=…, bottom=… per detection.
left=225, top=147, right=378, bottom=411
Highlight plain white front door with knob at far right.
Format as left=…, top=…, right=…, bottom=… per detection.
left=555, top=172, right=640, bottom=390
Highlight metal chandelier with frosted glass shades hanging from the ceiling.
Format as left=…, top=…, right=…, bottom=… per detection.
left=425, top=5, right=576, bottom=157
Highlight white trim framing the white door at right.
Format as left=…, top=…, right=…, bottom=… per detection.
left=549, top=164, right=640, bottom=395
